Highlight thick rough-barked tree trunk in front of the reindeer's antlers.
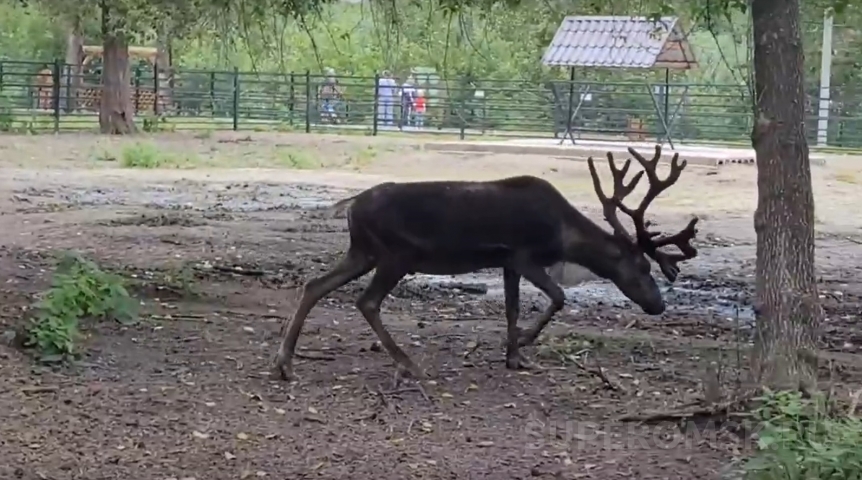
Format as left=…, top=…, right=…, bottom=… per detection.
left=751, top=0, right=822, bottom=390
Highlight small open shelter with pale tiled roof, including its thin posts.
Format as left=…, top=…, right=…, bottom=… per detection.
left=542, top=16, right=697, bottom=149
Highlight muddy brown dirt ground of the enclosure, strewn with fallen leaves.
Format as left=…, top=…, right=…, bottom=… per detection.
left=0, top=133, right=862, bottom=480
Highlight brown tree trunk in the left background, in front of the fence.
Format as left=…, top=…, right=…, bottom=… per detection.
left=99, top=1, right=135, bottom=135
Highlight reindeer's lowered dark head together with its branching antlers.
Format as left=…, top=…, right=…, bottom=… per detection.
left=587, top=145, right=698, bottom=315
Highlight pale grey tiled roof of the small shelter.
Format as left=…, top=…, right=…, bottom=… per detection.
left=542, top=16, right=697, bottom=70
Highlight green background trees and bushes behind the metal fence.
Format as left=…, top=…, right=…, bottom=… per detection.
left=0, top=0, right=862, bottom=145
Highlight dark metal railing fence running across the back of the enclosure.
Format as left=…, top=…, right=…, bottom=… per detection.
left=0, top=61, right=862, bottom=148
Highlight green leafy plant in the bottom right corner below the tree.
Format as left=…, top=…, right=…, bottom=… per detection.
left=745, top=391, right=862, bottom=480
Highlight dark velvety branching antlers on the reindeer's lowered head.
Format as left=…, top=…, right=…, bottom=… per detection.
left=587, top=145, right=698, bottom=282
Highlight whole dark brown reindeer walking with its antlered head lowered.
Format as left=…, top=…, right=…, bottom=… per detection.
left=272, top=145, right=698, bottom=380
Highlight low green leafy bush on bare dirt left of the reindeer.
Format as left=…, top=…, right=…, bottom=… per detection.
left=27, top=254, right=135, bottom=361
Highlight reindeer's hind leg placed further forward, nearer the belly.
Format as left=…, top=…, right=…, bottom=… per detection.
left=356, top=263, right=427, bottom=379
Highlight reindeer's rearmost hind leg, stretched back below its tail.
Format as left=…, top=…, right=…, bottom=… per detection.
left=272, top=250, right=374, bottom=380
